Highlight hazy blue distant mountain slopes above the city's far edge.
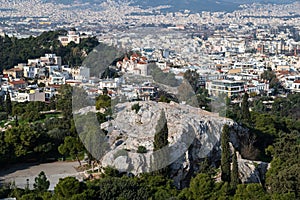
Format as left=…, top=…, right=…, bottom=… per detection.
left=45, top=0, right=296, bottom=12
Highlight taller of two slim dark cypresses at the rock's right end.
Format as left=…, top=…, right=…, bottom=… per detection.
left=221, top=124, right=230, bottom=182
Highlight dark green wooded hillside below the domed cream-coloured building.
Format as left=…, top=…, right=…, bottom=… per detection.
left=0, top=30, right=99, bottom=71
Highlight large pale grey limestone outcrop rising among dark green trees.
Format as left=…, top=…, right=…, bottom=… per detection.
left=100, top=101, right=264, bottom=187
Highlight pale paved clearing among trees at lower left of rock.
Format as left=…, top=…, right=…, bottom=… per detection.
left=0, top=162, right=83, bottom=190
